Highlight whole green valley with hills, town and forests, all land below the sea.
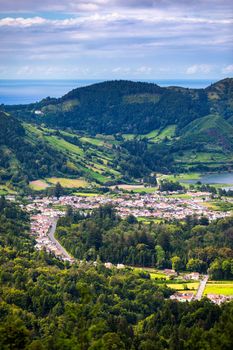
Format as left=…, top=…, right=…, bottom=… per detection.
left=0, top=79, right=233, bottom=350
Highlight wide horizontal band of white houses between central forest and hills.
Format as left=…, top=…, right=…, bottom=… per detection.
left=26, top=192, right=231, bottom=221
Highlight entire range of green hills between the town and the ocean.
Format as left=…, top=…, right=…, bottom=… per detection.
left=0, top=79, right=233, bottom=191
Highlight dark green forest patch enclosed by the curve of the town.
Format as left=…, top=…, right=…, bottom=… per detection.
left=57, top=206, right=233, bottom=279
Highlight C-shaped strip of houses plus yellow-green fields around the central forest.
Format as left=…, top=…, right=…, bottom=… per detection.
left=22, top=186, right=233, bottom=305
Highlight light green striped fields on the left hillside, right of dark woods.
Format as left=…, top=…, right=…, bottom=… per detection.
left=24, top=124, right=121, bottom=189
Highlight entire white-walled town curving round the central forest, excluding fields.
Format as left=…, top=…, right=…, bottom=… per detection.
left=22, top=192, right=232, bottom=304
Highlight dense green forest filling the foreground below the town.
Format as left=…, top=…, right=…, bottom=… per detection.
left=0, top=198, right=233, bottom=350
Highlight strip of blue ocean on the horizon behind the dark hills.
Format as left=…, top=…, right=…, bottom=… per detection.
left=0, top=79, right=215, bottom=105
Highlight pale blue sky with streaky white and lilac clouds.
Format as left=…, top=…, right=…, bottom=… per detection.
left=0, top=0, right=233, bottom=80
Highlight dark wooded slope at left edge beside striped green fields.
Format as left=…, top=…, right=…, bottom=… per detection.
left=0, top=112, right=83, bottom=187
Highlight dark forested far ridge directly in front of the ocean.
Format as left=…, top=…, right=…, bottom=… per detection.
left=5, top=79, right=233, bottom=135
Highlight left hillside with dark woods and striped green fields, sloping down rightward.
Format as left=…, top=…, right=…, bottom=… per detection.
left=0, top=112, right=177, bottom=193
